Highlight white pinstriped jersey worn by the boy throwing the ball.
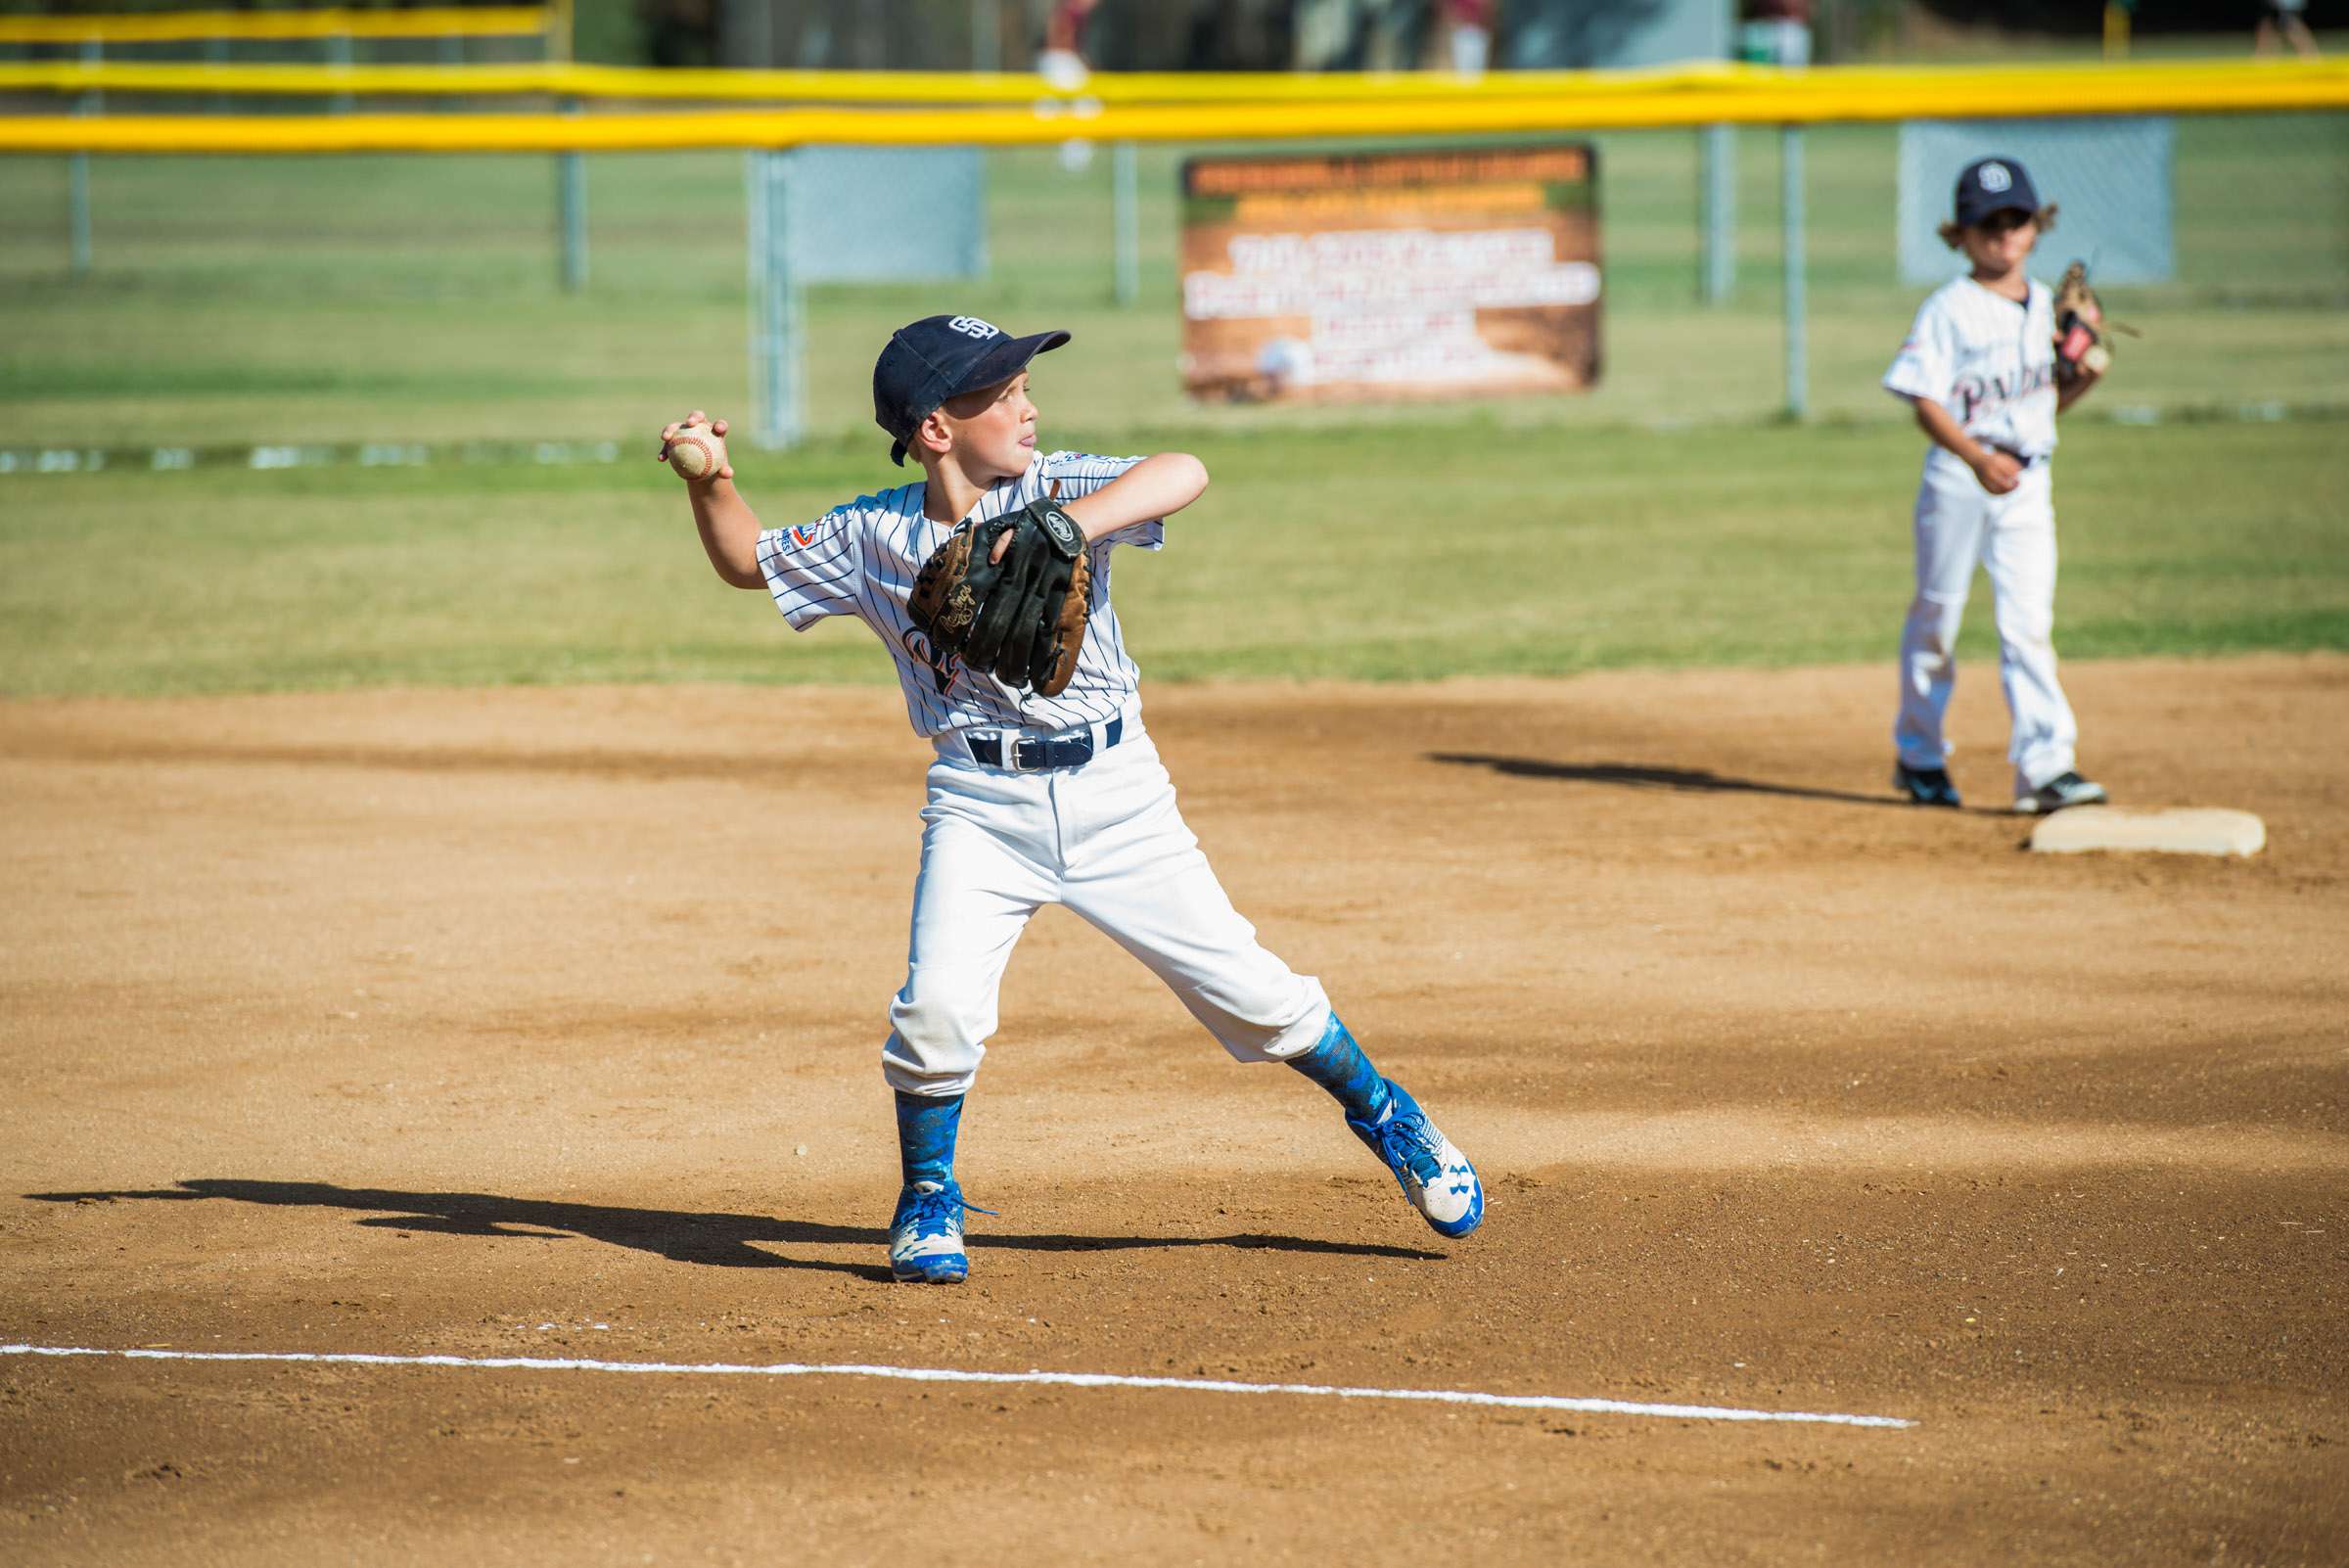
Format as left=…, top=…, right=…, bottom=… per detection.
left=759, top=450, right=1165, bottom=739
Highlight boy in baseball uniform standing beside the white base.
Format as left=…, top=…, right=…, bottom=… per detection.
left=1884, top=158, right=2104, bottom=812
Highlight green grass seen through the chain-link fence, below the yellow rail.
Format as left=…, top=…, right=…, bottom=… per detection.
left=0, top=113, right=2349, bottom=452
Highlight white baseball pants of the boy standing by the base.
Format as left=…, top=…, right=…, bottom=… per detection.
left=1893, top=448, right=2079, bottom=796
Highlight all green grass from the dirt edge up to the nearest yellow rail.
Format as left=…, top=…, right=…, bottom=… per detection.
left=0, top=101, right=2349, bottom=695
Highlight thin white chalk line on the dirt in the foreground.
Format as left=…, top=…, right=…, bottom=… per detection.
left=0, top=1345, right=1916, bottom=1427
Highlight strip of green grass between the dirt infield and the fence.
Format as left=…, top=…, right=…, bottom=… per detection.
left=0, top=420, right=2349, bottom=695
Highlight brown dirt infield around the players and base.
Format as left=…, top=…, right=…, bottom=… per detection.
left=0, top=657, right=2349, bottom=1566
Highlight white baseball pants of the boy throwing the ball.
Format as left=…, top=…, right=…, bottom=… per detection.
left=881, top=718, right=1329, bottom=1096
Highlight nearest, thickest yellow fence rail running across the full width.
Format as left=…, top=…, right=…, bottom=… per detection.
left=0, top=61, right=2349, bottom=153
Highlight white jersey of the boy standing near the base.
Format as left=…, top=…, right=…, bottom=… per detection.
left=1884, top=277, right=2055, bottom=458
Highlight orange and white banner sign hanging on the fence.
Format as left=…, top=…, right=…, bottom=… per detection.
left=1181, top=143, right=1599, bottom=401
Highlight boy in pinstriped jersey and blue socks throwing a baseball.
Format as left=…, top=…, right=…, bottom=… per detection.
left=660, top=317, right=1485, bottom=1284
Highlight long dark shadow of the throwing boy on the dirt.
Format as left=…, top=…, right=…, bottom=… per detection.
left=25, top=1180, right=1445, bottom=1279
